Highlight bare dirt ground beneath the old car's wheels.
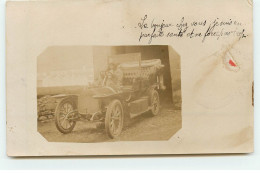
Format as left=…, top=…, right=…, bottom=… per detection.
left=38, top=102, right=182, bottom=143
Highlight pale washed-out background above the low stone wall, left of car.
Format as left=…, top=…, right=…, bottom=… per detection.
left=37, top=46, right=94, bottom=87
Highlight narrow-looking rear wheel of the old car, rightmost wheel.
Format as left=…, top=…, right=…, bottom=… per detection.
left=150, top=89, right=160, bottom=116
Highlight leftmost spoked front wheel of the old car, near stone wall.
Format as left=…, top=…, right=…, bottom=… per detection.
left=55, top=98, right=76, bottom=134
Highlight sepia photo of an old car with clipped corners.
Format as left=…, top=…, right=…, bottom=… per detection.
left=36, top=45, right=182, bottom=143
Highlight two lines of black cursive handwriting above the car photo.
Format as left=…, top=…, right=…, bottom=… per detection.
left=137, top=15, right=247, bottom=44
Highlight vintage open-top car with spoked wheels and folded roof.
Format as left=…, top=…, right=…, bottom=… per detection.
left=55, top=59, right=165, bottom=138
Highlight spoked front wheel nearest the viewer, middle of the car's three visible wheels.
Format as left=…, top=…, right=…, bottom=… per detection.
left=105, top=99, right=124, bottom=139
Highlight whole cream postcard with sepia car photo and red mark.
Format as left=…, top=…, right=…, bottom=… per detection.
left=6, top=0, right=254, bottom=156
